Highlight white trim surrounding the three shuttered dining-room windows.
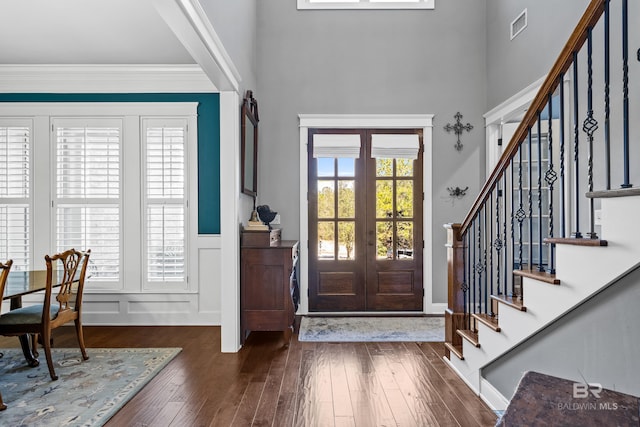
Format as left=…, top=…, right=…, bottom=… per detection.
left=0, top=102, right=199, bottom=294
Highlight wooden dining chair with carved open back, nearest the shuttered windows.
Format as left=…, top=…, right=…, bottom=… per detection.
left=0, top=249, right=91, bottom=380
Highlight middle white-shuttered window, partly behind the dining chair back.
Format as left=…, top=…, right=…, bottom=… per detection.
left=52, top=118, right=122, bottom=282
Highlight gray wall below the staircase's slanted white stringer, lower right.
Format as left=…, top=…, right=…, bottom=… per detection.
left=483, top=269, right=640, bottom=398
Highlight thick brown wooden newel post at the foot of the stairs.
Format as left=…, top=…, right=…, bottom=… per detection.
left=445, top=224, right=468, bottom=357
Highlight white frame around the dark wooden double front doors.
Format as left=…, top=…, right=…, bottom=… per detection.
left=297, top=114, right=442, bottom=314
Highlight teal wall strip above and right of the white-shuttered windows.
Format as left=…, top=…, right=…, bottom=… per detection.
left=0, top=93, right=220, bottom=234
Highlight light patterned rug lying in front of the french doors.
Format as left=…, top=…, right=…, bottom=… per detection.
left=298, top=316, right=444, bottom=342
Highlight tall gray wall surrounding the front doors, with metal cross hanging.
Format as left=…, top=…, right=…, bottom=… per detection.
left=257, top=0, right=487, bottom=303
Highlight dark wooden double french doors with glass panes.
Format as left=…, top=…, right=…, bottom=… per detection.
left=308, top=129, right=424, bottom=311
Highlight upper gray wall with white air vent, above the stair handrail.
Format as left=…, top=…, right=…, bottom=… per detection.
left=490, top=0, right=589, bottom=110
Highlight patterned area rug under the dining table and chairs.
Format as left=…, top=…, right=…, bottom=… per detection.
left=0, top=348, right=181, bottom=427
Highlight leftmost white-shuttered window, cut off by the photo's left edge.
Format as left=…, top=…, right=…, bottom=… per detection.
left=0, top=119, right=33, bottom=270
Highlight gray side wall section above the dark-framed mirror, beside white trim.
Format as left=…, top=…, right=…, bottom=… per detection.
left=200, top=0, right=258, bottom=96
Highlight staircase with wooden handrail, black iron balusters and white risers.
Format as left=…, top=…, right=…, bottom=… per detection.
left=445, top=0, right=640, bottom=410
